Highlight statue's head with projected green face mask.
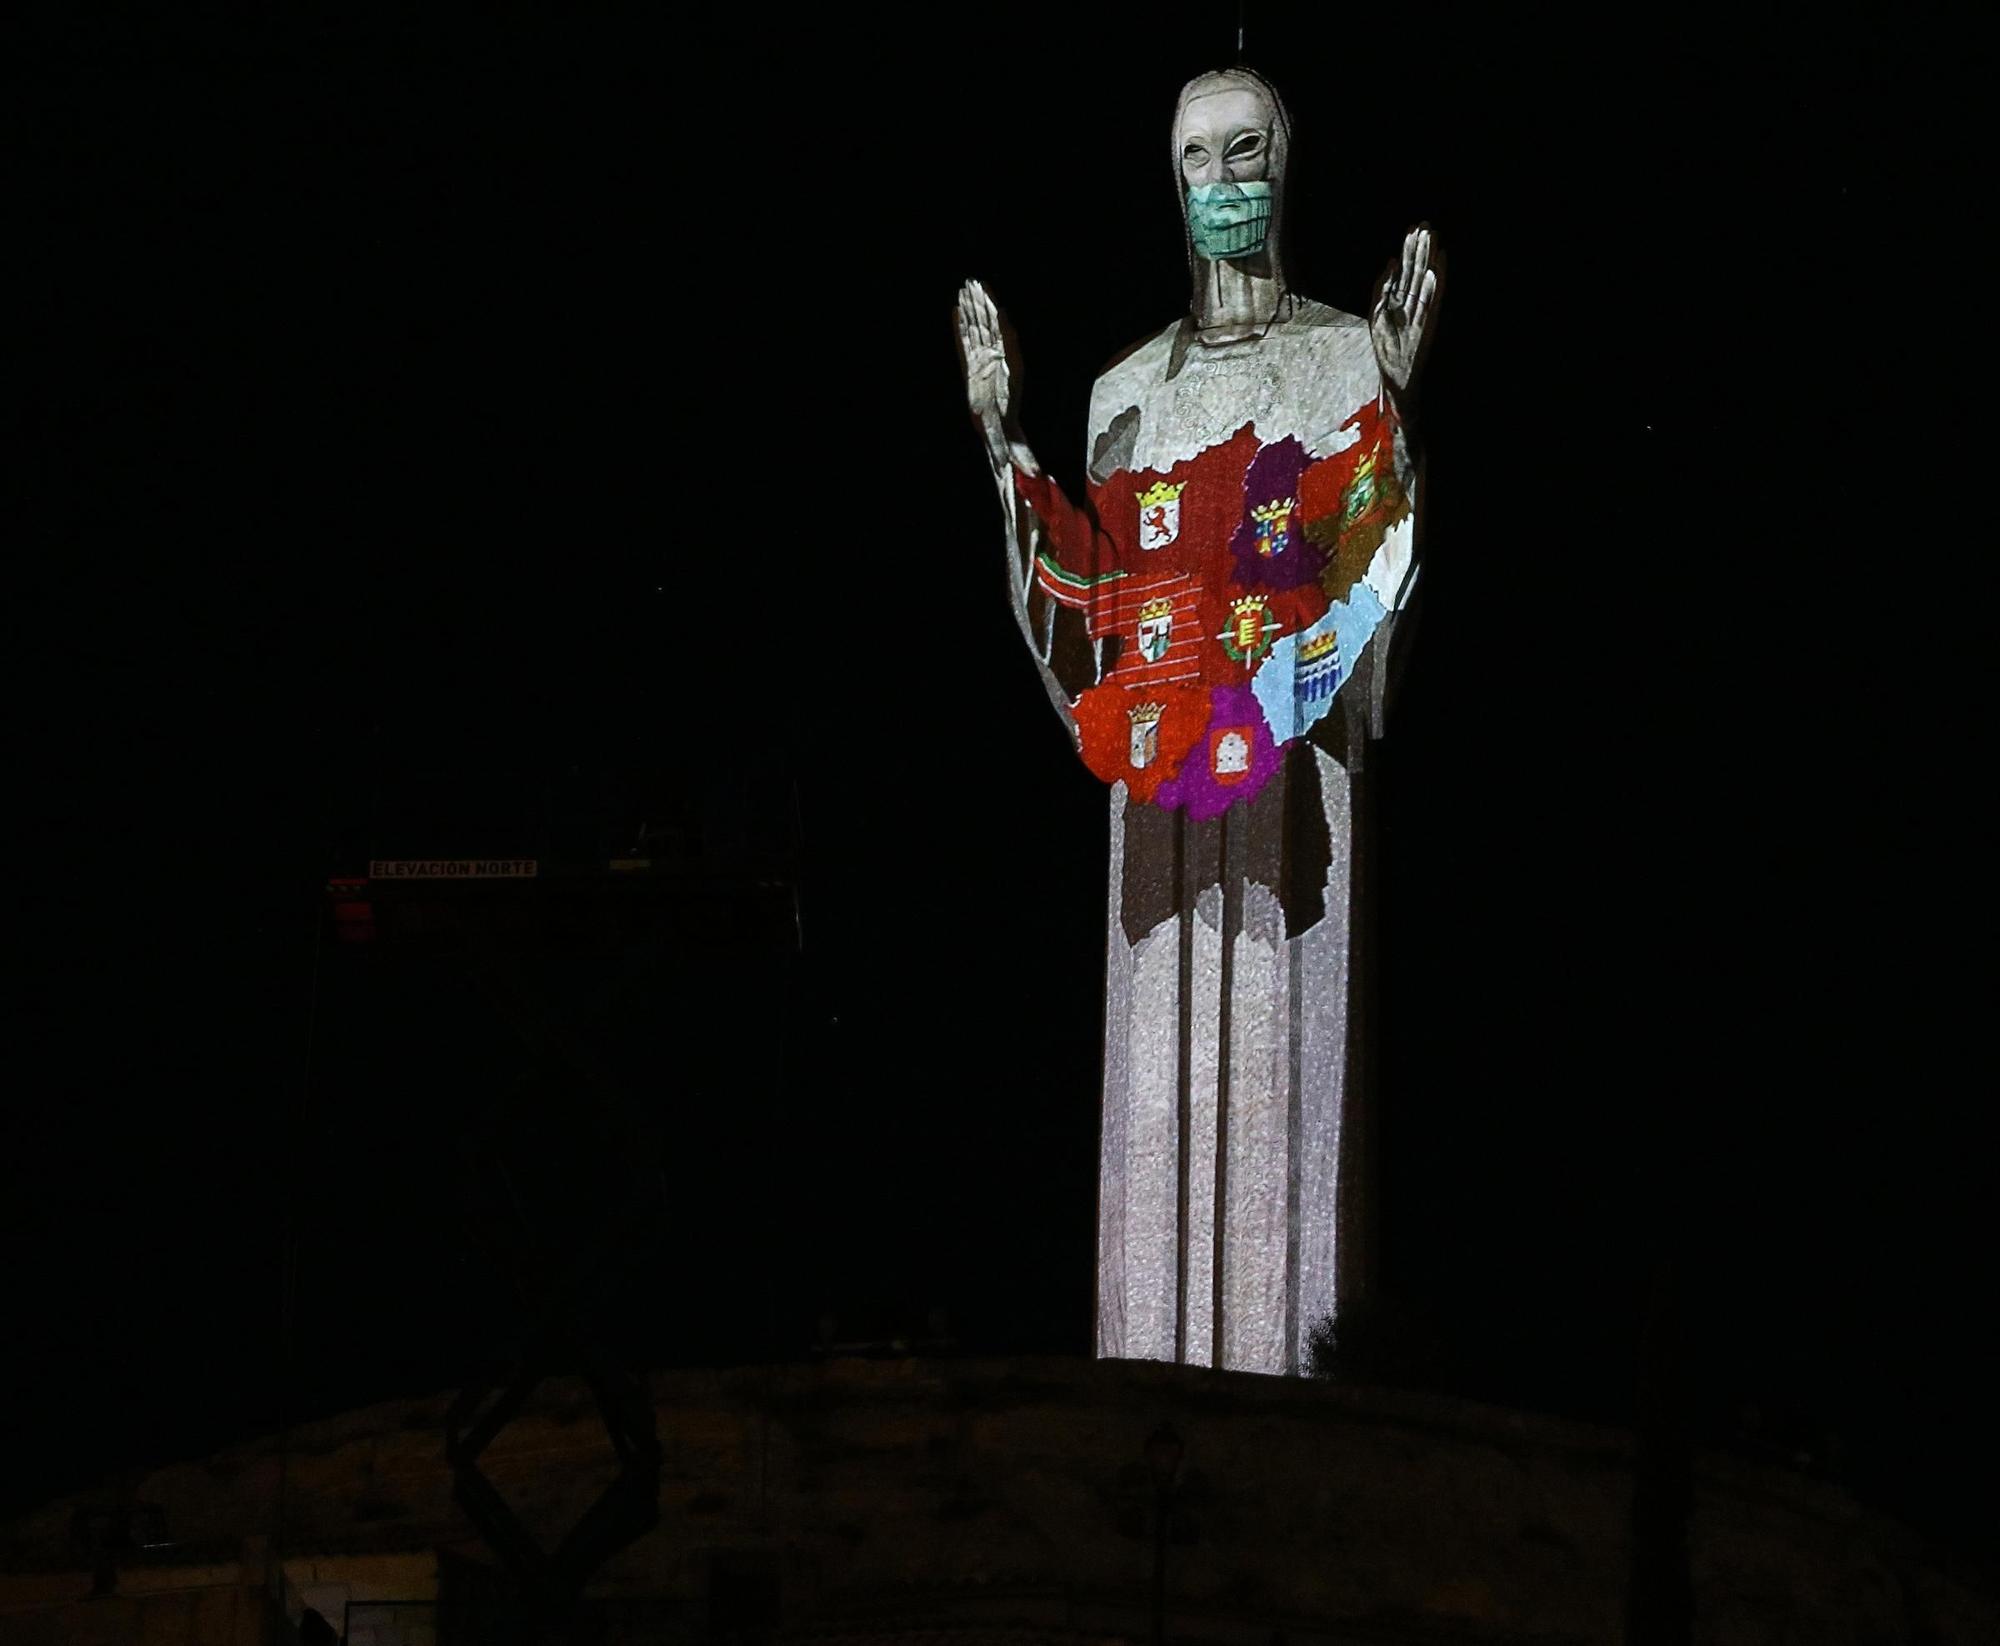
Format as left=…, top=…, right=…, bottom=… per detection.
left=1174, top=68, right=1290, bottom=278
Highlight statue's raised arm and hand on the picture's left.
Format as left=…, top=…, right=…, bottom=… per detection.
left=958, top=280, right=1096, bottom=720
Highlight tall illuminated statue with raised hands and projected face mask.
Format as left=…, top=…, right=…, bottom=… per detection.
left=958, top=70, right=1438, bottom=1372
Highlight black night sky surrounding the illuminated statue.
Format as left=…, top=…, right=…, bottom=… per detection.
left=0, top=4, right=1994, bottom=1568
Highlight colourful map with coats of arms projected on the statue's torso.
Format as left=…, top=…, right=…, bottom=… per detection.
left=1010, top=400, right=1410, bottom=816
